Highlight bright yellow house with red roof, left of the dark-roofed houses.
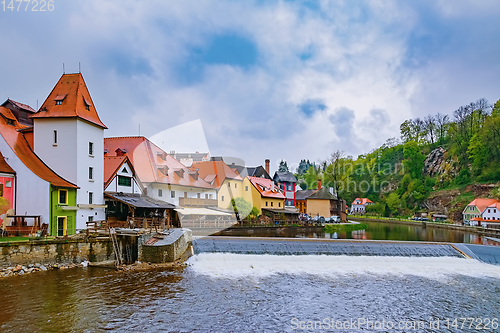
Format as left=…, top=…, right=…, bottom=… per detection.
left=243, top=176, right=285, bottom=214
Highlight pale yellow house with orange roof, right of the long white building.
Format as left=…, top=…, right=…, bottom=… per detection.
left=190, top=161, right=244, bottom=209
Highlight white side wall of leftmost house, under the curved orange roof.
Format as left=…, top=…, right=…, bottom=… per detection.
left=0, top=135, right=51, bottom=225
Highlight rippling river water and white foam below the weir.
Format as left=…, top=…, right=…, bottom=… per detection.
left=0, top=254, right=500, bottom=332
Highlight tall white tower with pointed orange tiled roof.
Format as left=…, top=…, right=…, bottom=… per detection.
left=31, top=73, right=107, bottom=229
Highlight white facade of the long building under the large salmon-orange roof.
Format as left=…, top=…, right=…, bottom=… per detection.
left=147, top=183, right=217, bottom=206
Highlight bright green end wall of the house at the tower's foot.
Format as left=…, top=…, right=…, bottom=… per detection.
left=49, top=186, right=76, bottom=236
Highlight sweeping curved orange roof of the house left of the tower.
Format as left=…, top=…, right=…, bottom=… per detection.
left=0, top=106, right=78, bottom=188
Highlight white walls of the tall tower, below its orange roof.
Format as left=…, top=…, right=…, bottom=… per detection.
left=34, top=118, right=106, bottom=229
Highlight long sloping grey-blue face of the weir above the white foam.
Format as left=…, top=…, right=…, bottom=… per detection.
left=193, top=237, right=466, bottom=258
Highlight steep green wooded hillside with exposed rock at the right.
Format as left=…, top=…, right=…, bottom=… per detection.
left=296, top=99, right=500, bottom=221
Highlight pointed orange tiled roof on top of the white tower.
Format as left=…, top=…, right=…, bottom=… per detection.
left=31, top=73, right=107, bottom=128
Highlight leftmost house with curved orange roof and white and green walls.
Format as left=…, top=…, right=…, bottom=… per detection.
left=0, top=106, right=78, bottom=236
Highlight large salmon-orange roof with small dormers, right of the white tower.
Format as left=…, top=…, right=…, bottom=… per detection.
left=104, top=136, right=214, bottom=189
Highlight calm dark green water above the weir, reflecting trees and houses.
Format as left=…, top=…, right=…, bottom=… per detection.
left=215, top=222, right=499, bottom=245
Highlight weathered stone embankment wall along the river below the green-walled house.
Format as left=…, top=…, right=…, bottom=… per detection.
left=0, top=240, right=115, bottom=268
